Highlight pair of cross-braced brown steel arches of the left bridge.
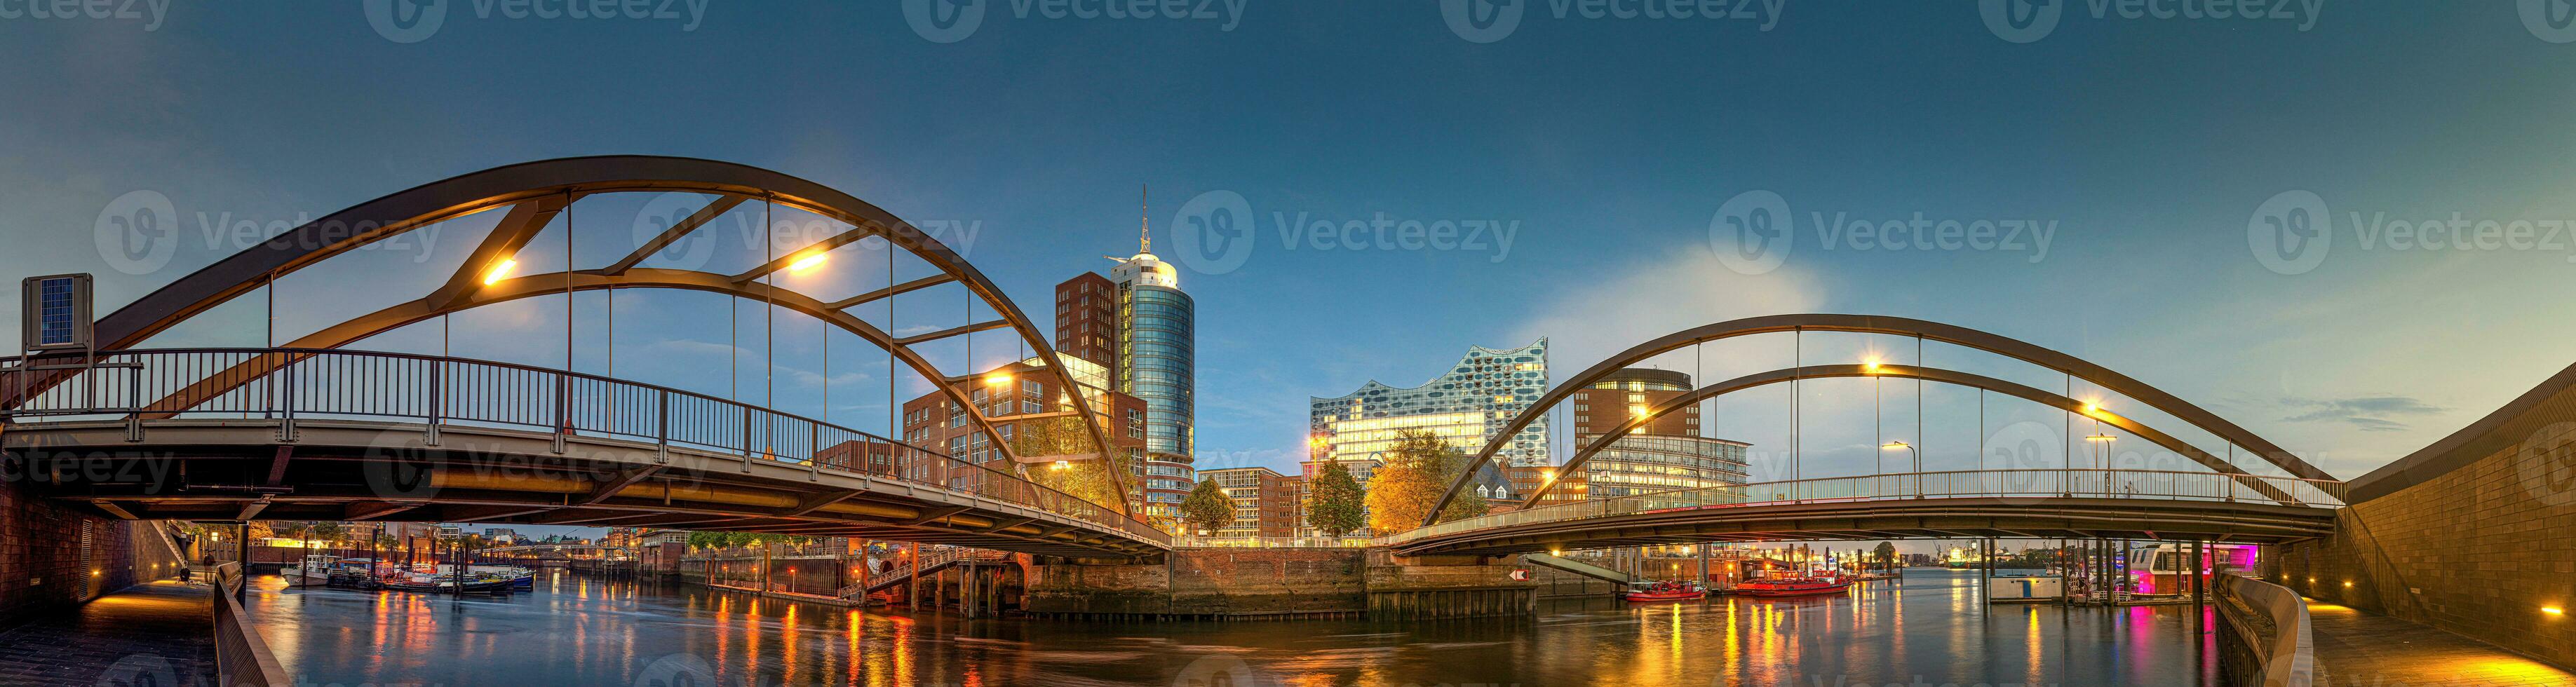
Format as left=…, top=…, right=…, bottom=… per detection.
left=0, top=154, right=1133, bottom=515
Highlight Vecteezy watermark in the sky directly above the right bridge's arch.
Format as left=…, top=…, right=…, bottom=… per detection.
left=1708, top=191, right=2058, bottom=276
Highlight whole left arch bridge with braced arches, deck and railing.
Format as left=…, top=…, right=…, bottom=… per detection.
left=0, top=157, right=1170, bottom=556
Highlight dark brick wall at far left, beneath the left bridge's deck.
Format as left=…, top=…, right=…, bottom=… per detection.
left=0, top=481, right=134, bottom=625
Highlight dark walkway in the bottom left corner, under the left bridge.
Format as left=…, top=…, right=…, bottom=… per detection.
left=0, top=582, right=214, bottom=687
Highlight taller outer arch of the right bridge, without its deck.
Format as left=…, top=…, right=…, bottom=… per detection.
left=1422, top=314, right=2334, bottom=525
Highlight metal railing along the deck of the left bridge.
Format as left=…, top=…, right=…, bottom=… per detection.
left=0, top=348, right=1170, bottom=545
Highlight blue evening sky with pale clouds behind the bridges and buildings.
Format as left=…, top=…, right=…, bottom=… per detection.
left=0, top=0, right=2576, bottom=543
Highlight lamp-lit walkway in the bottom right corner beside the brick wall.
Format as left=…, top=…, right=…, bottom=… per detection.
left=2308, top=602, right=2576, bottom=687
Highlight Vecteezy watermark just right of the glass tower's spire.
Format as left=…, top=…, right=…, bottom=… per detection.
left=1167, top=191, right=1520, bottom=276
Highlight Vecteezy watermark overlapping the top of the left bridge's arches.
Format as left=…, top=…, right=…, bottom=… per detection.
left=628, top=191, right=984, bottom=270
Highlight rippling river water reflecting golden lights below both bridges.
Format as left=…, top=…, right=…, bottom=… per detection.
left=250, top=569, right=2216, bottom=687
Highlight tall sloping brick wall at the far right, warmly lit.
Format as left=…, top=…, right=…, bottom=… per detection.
left=2262, top=368, right=2576, bottom=667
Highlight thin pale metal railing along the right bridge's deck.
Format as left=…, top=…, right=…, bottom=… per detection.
left=1375, top=468, right=2344, bottom=545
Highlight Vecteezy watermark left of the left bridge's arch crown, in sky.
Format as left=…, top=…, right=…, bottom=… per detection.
left=90, top=191, right=443, bottom=276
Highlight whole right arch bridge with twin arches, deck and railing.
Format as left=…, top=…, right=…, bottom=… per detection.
left=1381, top=314, right=2344, bottom=556
